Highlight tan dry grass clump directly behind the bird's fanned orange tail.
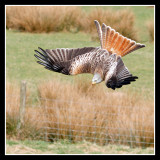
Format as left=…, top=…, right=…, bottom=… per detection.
left=83, top=8, right=138, bottom=40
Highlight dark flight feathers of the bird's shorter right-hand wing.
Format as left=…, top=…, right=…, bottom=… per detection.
left=106, top=56, right=138, bottom=90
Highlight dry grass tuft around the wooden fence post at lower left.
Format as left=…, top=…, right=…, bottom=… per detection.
left=6, top=82, right=43, bottom=139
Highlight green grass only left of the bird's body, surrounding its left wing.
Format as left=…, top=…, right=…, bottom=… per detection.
left=6, top=30, right=98, bottom=94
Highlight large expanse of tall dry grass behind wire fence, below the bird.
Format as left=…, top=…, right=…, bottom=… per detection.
left=38, top=80, right=154, bottom=146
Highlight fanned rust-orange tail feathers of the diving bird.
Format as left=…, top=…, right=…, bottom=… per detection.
left=94, top=20, right=145, bottom=57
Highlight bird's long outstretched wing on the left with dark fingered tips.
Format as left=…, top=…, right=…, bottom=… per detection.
left=34, top=47, right=101, bottom=75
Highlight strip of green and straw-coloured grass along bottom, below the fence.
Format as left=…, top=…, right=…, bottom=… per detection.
left=6, top=140, right=154, bottom=154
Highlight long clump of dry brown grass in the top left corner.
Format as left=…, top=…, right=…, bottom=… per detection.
left=6, top=6, right=81, bottom=33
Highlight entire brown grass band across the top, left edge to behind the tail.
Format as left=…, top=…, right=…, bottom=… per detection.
left=6, top=6, right=137, bottom=40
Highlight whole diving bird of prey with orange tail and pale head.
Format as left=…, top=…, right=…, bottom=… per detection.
left=34, top=20, right=145, bottom=90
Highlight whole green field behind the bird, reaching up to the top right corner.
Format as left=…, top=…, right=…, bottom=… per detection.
left=6, top=6, right=154, bottom=91
